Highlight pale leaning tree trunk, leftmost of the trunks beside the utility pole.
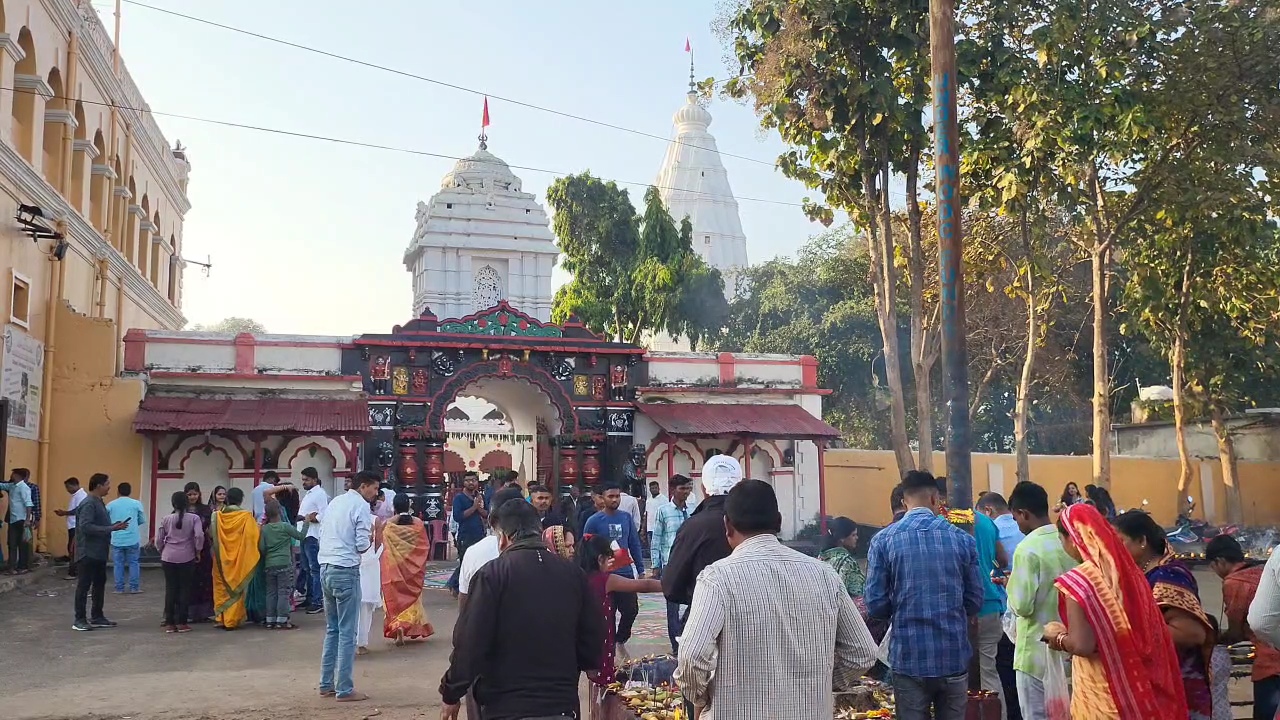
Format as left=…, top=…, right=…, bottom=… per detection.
left=859, top=135, right=915, bottom=475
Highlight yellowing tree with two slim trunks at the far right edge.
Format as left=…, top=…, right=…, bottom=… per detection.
left=1124, top=163, right=1280, bottom=521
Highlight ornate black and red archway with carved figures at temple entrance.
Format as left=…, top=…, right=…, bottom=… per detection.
left=342, top=301, right=648, bottom=520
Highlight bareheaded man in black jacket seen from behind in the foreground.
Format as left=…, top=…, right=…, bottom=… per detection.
left=440, top=500, right=605, bottom=720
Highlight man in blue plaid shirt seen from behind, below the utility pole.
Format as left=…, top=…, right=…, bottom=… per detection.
left=863, top=470, right=983, bottom=720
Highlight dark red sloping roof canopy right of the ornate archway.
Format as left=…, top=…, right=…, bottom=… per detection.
left=639, top=402, right=840, bottom=439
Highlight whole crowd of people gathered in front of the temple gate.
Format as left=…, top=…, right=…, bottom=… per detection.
left=10, top=456, right=1280, bottom=720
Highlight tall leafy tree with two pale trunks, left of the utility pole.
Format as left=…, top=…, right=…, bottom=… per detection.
left=726, top=0, right=932, bottom=471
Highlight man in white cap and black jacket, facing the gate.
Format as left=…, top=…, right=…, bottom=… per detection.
left=662, top=455, right=742, bottom=650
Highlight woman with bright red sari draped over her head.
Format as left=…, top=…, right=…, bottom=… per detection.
left=1043, top=503, right=1187, bottom=720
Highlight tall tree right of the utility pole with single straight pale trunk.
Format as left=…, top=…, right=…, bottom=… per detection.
left=960, top=0, right=1277, bottom=484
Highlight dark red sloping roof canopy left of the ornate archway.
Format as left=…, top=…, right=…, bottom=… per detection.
left=133, top=397, right=369, bottom=433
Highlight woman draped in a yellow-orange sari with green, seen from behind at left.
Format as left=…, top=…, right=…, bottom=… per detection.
left=212, top=488, right=260, bottom=630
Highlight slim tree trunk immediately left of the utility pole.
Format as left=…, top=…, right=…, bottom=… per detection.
left=906, top=147, right=933, bottom=473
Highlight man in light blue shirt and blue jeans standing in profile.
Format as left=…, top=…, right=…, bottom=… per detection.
left=320, top=470, right=383, bottom=702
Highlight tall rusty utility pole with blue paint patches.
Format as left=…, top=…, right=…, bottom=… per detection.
left=929, top=0, right=973, bottom=510
